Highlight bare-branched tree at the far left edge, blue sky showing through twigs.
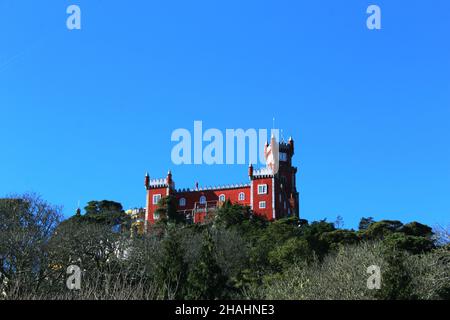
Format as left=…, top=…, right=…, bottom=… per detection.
left=0, top=194, right=62, bottom=292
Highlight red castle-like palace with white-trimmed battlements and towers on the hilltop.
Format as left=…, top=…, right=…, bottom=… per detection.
left=144, top=138, right=299, bottom=229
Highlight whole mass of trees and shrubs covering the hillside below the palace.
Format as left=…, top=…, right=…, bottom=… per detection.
left=0, top=197, right=450, bottom=299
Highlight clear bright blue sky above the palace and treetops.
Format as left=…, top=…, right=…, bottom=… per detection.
left=0, top=0, right=450, bottom=227
